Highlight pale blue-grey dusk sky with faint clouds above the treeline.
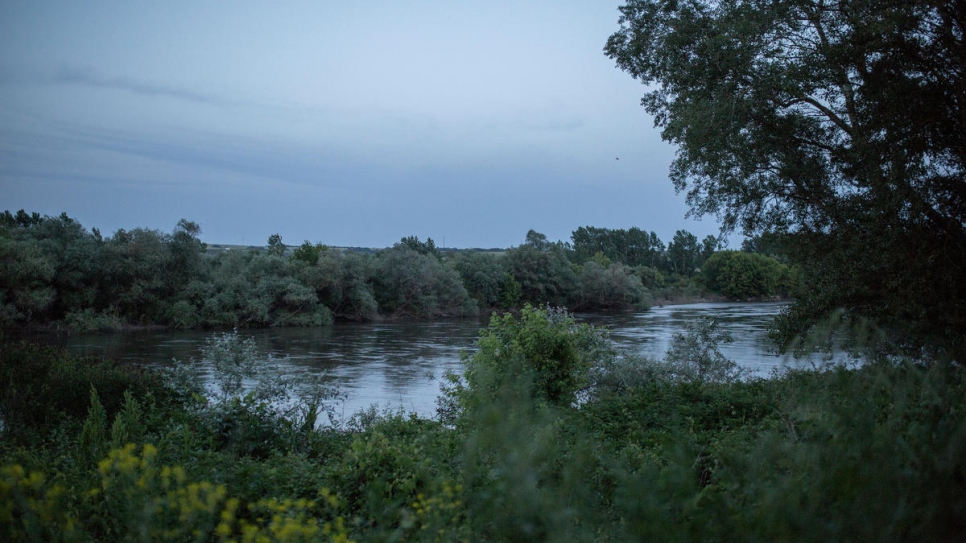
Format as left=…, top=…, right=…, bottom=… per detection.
left=0, top=0, right=718, bottom=248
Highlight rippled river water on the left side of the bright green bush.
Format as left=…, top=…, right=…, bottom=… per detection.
left=45, top=319, right=486, bottom=417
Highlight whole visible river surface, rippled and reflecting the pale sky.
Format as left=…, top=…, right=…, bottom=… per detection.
left=36, top=303, right=824, bottom=417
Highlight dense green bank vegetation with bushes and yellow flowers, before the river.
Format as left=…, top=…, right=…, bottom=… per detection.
left=0, top=307, right=966, bottom=541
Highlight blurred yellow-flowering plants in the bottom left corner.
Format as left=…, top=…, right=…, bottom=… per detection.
left=0, top=444, right=358, bottom=542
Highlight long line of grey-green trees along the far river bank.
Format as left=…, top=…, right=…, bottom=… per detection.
left=0, top=210, right=792, bottom=330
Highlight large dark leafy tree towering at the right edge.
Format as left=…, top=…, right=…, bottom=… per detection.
left=605, top=0, right=966, bottom=361
